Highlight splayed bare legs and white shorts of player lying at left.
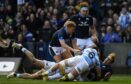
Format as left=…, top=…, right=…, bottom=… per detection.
left=7, top=42, right=55, bottom=79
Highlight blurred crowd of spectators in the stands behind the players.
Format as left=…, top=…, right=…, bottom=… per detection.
left=0, top=0, right=131, bottom=43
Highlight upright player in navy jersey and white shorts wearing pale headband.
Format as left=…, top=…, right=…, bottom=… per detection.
left=69, top=3, right=98, bottom=49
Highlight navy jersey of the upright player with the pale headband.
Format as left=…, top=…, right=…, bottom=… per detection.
left=69, top=14, right=93, bottom=39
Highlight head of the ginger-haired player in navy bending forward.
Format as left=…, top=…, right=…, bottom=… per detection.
left=64, top=21, right=76, bottom=34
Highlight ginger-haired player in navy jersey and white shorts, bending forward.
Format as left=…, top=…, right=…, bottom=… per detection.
left=49, top=21, right=80, bottom=62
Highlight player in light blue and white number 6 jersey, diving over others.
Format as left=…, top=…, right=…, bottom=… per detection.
left=42, top=48, right=100, bottom=81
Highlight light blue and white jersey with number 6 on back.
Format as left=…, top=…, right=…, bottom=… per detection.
left=82, top=48, right=100, bottom=68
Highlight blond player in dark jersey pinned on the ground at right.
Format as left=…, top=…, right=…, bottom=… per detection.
left=87, top=53, right=116, bottom=81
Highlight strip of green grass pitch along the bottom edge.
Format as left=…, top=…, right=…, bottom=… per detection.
left=0, top=75, right=131, bottom=84
